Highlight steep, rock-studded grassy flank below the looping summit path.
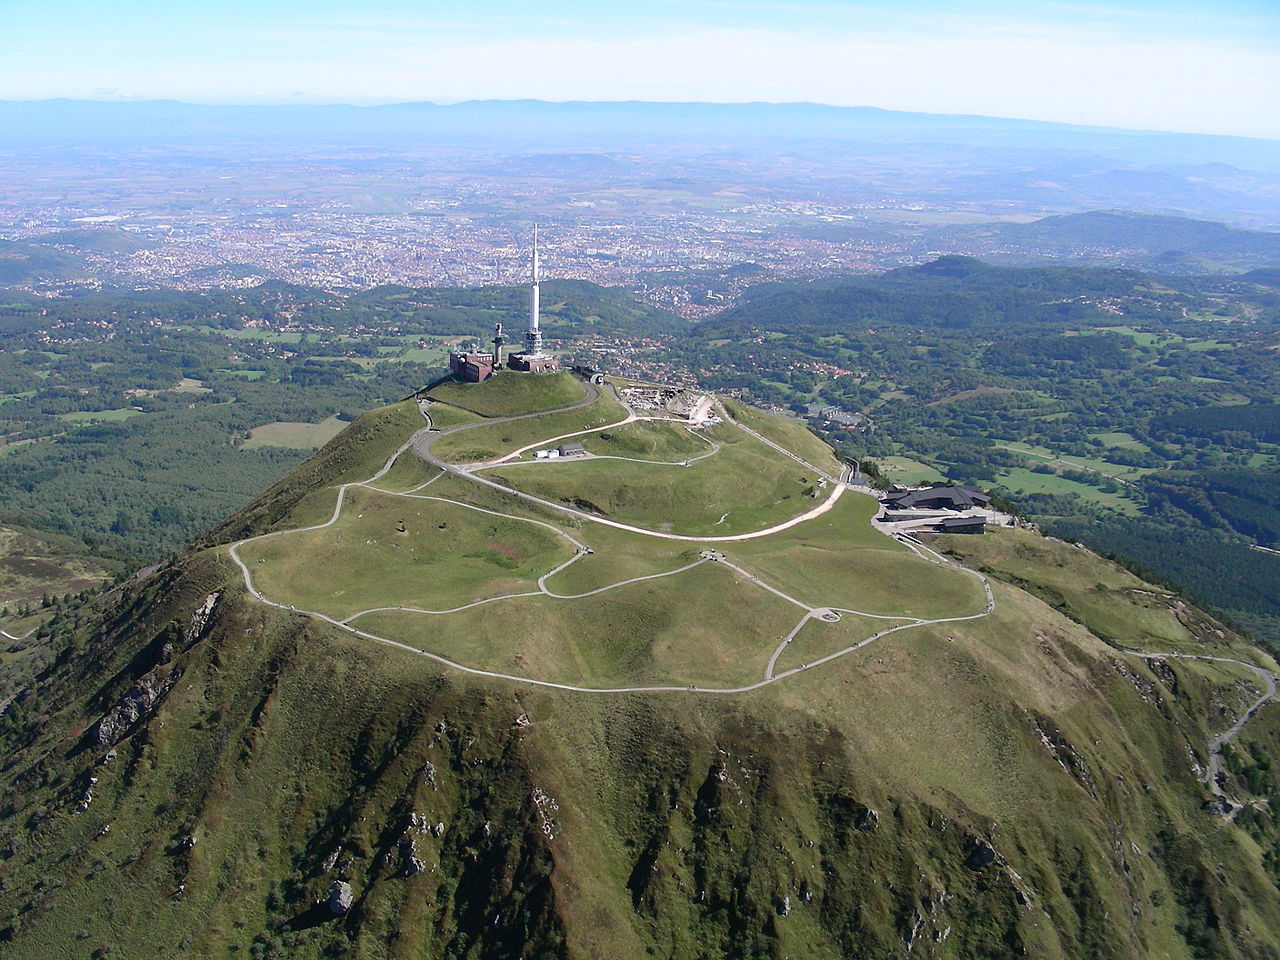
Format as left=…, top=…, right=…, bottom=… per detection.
left=0, top=389, right=1280, bottom=960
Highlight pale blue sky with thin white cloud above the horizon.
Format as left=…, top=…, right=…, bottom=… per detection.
left=0, top=0, right=1280, bottom=140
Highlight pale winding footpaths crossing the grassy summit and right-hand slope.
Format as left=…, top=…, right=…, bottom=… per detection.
left=225, top=384, right=1277, bottom=799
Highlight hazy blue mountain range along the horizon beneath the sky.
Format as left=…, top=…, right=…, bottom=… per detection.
left=0, top=100, right=1280, bottom=170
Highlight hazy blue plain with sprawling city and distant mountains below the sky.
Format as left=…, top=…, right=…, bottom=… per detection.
left=10, top=101, right=1280, bottom=317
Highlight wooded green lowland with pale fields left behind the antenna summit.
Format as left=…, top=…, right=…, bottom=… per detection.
left=0, top=282, right=676, bottom=559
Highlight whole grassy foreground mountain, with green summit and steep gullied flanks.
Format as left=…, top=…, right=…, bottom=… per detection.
left=0, top=384, right=1280, bottom=960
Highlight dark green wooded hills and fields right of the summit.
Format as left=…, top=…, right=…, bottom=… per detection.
left=676, top=257, right=1280, bottom=641
